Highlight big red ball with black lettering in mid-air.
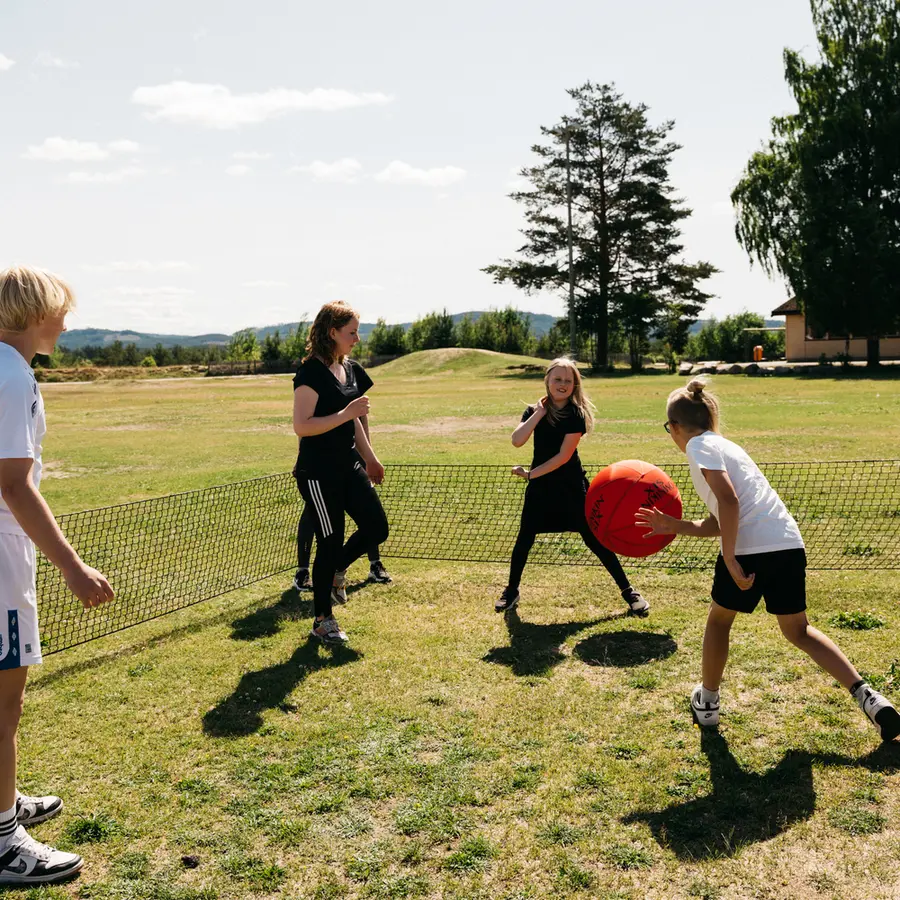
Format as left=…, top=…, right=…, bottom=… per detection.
left=584, top=459, right=681, bottom=556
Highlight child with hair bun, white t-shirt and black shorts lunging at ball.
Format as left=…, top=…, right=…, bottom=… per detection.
left=636, top=379, right=900, bottom=741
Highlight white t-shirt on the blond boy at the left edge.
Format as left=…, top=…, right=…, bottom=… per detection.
left=0, top=341, right=47, bottom=535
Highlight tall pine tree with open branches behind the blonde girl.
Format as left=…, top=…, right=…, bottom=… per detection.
left=484, top=82, right=716, bottom=368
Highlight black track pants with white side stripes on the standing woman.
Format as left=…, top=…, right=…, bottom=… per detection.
left=297, top=466, right=388, bottom=616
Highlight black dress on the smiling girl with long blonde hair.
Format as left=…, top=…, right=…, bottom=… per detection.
left=519, top=403, right=588, bottom=534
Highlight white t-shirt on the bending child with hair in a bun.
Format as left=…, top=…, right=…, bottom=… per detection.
left=686, top=431, right=804, bottom=554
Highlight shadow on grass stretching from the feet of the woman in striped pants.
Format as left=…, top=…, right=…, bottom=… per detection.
left=203, top=639, right=362, bottom=737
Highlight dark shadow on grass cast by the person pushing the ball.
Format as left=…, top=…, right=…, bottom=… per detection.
left=622, top=731, right=900, bottom=860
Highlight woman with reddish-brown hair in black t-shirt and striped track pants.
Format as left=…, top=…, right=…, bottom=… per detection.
left=294, top=302, right=388, bottom=644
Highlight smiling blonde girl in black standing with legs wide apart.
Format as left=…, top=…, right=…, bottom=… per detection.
left=494, top=359, right=650, bottom=615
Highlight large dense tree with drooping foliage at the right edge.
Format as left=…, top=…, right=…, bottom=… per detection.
left=731, top=0, right=900, bottom=365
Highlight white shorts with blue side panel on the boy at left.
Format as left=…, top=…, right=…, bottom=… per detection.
left=0, top=534, right=41, bottom=669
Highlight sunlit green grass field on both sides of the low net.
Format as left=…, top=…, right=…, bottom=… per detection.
left=11, top=351, right=900, bottom=900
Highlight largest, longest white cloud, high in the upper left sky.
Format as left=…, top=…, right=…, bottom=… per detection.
left=131, top=81, right=393, bottom=128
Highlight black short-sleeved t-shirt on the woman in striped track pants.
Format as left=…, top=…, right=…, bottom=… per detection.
left=294, top=357, right=372, bottom=475
